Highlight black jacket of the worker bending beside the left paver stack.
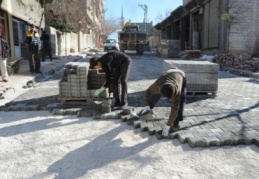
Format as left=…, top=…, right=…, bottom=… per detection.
left=98, top=51, right=131, bottom=88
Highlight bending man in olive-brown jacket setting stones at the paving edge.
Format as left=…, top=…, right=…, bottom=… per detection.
left=139, top=68, right=186, bottom=136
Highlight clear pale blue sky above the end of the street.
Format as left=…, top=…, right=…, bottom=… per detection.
left=104, top=0, right=183, bottom=38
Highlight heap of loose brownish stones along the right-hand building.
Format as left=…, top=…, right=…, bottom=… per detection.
left=213, top=53, right=259, bottom=72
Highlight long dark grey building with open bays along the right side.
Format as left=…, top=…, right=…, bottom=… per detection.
left=155, top=0, right=259, bottom=56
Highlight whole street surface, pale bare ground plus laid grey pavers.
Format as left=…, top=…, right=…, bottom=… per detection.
left=0, top=53, right=259, bottom=179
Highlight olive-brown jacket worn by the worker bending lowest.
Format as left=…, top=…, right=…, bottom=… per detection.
left=144, top=68, right=185, bottom=126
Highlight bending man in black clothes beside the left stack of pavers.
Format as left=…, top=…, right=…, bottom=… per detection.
left=90, top=51, right=131, bottom=107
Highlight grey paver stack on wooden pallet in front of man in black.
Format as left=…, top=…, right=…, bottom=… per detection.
left=59, top=62, right=108, bottom=100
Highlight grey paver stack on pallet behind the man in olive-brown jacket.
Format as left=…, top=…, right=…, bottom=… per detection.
left=163, top=60, right=219, bottom=96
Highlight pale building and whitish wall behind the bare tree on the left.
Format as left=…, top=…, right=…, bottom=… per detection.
left=46, top=0, right=104, bottom=55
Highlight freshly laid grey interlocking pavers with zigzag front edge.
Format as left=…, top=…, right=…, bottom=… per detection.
left=2, top=55, right=259, bottom=147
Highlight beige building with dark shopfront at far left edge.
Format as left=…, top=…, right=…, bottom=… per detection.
left=0, top=0, right=45, bottom=57
